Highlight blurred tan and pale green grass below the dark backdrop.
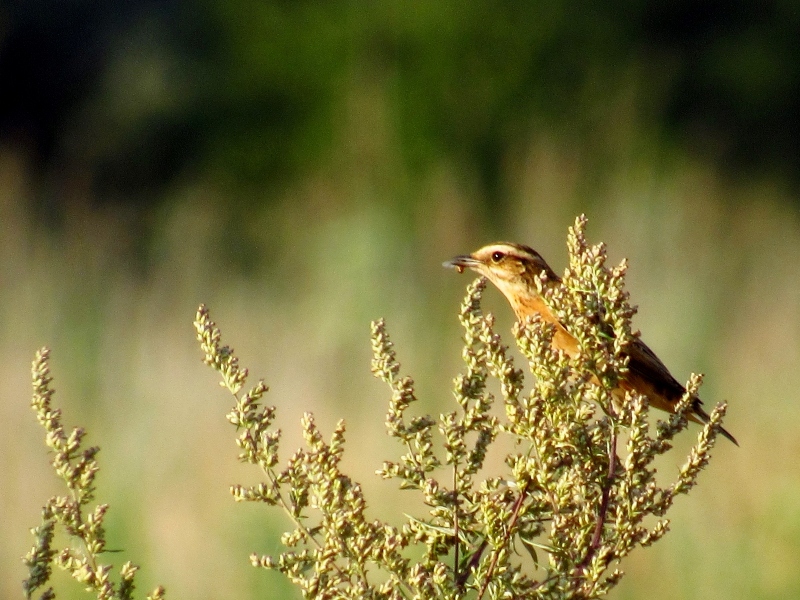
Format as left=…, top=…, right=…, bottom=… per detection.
left=0, top=97, right=800, bottom=600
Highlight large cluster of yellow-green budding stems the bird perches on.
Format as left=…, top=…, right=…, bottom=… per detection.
left=195, top=218, right=725, bottom=599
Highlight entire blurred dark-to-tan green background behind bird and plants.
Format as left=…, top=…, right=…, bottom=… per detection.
left=0, top=0, right=800, bottom=599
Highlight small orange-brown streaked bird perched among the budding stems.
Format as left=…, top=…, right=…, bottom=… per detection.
left=443, top=242, right=739, bottom=446
